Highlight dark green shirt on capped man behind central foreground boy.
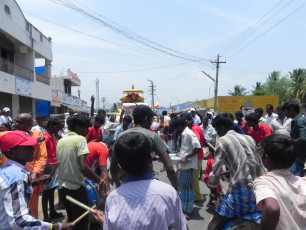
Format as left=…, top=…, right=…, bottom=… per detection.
left=117, top=127, right=168, bottom=156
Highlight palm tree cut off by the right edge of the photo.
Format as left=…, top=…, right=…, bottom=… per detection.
left=289, top=68, right=306, bottom=104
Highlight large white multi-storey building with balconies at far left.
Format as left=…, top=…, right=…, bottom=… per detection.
left=0, top=0, right=52, bottom=118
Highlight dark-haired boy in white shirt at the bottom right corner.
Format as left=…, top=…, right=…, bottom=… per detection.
left=253, top=134, right=306, bottom=230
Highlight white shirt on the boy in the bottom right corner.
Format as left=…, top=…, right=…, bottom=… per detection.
left=253, top=169, right=306, bottom=230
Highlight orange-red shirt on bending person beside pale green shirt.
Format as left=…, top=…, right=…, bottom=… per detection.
left=87, top=142, right=108, bottom=170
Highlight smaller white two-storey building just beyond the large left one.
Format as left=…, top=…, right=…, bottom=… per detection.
left=51, top=69, right=89, bottom=115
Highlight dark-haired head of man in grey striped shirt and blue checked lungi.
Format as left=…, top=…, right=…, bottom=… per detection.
left=212, top=113, right=234, bottom=137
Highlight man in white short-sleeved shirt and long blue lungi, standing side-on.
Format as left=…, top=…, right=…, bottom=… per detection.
left=173, top=117, right=201, bottom=220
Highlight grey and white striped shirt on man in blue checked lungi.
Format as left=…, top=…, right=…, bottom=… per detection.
left=208, top=130, right=265, bottom=192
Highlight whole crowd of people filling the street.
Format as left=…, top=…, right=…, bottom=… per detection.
left=0, top=97, right=306, bottom=230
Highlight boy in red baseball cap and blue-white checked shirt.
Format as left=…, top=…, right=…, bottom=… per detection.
left=0, top=130, right=72, bottom=230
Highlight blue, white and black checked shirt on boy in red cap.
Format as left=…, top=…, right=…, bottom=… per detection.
left=0, top=160, right=50, bottom=230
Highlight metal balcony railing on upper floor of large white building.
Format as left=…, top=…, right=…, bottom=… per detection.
left=0, top=57, right=34, bottom=81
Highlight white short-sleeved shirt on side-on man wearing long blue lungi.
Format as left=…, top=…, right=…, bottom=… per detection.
left=179, top=127, right=201, bottom=170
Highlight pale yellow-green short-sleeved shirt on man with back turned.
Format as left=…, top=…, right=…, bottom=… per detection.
left=56, top=132, right=89, bottom=190
